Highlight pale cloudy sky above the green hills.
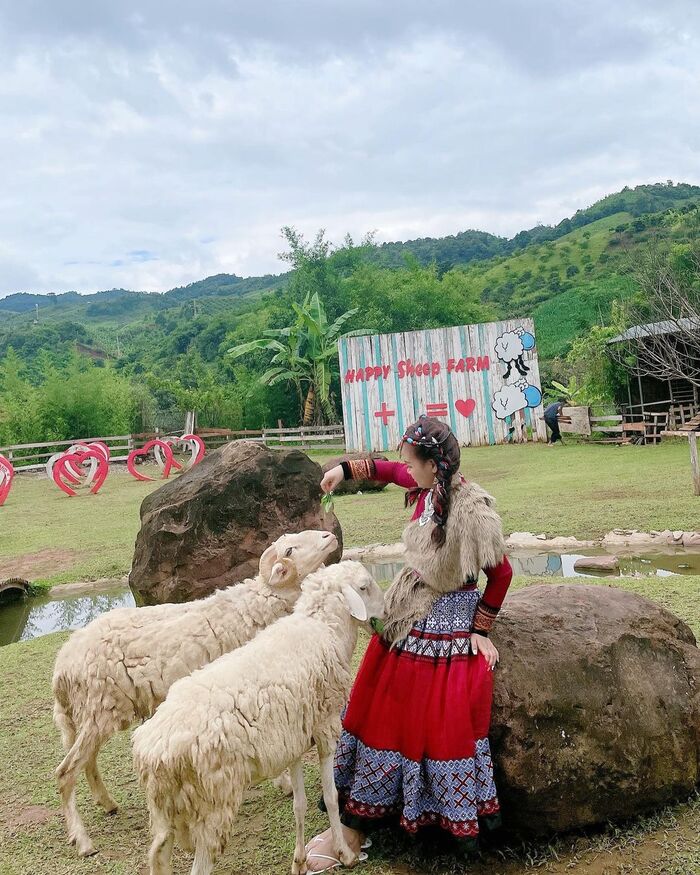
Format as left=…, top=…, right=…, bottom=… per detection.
left=0, top=0, right=700, bottom=296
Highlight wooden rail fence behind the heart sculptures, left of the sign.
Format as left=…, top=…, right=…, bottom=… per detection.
left=0, top=425, right=345, bottom=471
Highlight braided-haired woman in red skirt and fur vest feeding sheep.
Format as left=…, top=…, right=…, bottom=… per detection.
left=308, top=416, right=512, bottom=871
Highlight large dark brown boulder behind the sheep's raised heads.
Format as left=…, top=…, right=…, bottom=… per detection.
left=129, top=442, right=342, bottom=605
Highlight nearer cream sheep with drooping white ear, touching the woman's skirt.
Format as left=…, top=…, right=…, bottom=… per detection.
left=133, top=562, right=384, bottom=875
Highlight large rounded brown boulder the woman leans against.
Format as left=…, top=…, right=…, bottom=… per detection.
left=490, top=584, right=700, bottom=836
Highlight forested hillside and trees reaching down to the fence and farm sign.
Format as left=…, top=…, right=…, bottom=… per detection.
left=0, top=185, right=700, bottom=442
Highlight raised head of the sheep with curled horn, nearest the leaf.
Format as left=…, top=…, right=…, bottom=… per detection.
left=260, top=529, right=338, bottom=588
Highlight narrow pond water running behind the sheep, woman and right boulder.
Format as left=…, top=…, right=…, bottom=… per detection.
left=0, top=550, right=700, bottom=646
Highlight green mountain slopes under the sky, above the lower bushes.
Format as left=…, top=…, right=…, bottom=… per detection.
left=0, top=183, right=700, bottom=381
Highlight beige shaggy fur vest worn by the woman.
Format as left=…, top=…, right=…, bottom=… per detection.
left=384, top=474, right=506, bottom=644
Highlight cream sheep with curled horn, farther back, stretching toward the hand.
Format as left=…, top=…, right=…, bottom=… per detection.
left=53, top=531, right=338, bottom=856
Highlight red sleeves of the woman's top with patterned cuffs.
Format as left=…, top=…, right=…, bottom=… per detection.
left=343, top=459, right=513, bottom=635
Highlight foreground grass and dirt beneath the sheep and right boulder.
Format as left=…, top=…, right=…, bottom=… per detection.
left=0, top=577, right=700, bottom=875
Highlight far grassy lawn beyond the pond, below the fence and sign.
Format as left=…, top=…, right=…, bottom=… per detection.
left=0, top=441, right=700, bottom=583
